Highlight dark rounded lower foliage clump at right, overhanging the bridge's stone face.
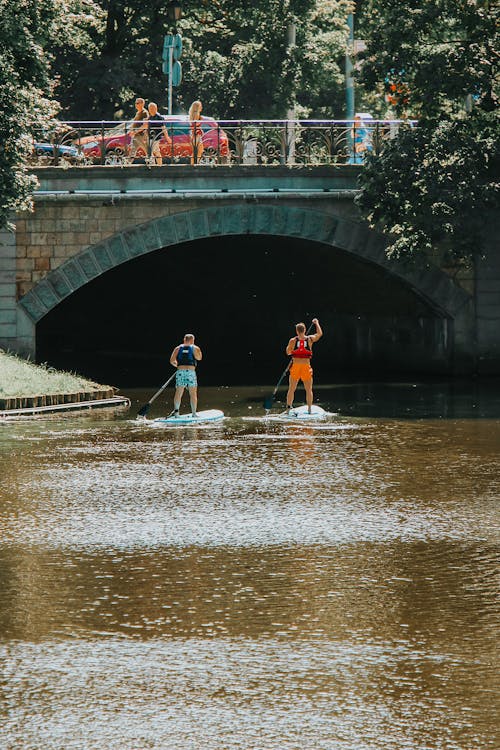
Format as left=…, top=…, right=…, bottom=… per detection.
left=357, top=111, right=500, bottom=262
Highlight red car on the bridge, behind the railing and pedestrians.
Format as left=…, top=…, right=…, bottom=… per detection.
left=74, top=115, right=229, bottom=164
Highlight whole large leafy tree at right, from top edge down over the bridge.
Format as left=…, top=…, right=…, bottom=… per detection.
left=357, top=0, right=500, bottom=261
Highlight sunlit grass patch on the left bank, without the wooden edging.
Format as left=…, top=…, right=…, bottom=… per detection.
left=0, top=350, right=110, bottom=399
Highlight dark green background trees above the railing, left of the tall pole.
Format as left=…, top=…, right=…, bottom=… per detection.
left=55, top=0, right=352, bottom=119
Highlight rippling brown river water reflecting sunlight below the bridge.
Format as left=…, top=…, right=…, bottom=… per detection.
left=0, top=384, right=500, bottom=750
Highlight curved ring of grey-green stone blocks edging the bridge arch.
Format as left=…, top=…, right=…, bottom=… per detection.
left=18, top=204, right=470, bottom=323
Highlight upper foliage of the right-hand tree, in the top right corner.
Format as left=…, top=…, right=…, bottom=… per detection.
left=360, top=0, right=499, bottom=120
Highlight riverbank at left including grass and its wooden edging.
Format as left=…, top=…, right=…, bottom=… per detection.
left=0, top=350, right=128, bottom=416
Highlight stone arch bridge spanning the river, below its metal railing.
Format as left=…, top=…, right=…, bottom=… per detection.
left=0, top=166, right=500, bottom=382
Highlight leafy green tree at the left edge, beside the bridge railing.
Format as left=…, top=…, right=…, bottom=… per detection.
left=0, top=0, right=101, bottom=227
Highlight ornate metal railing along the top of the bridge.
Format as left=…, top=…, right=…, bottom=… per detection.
left=28, top=116, right=416, bottom=168
